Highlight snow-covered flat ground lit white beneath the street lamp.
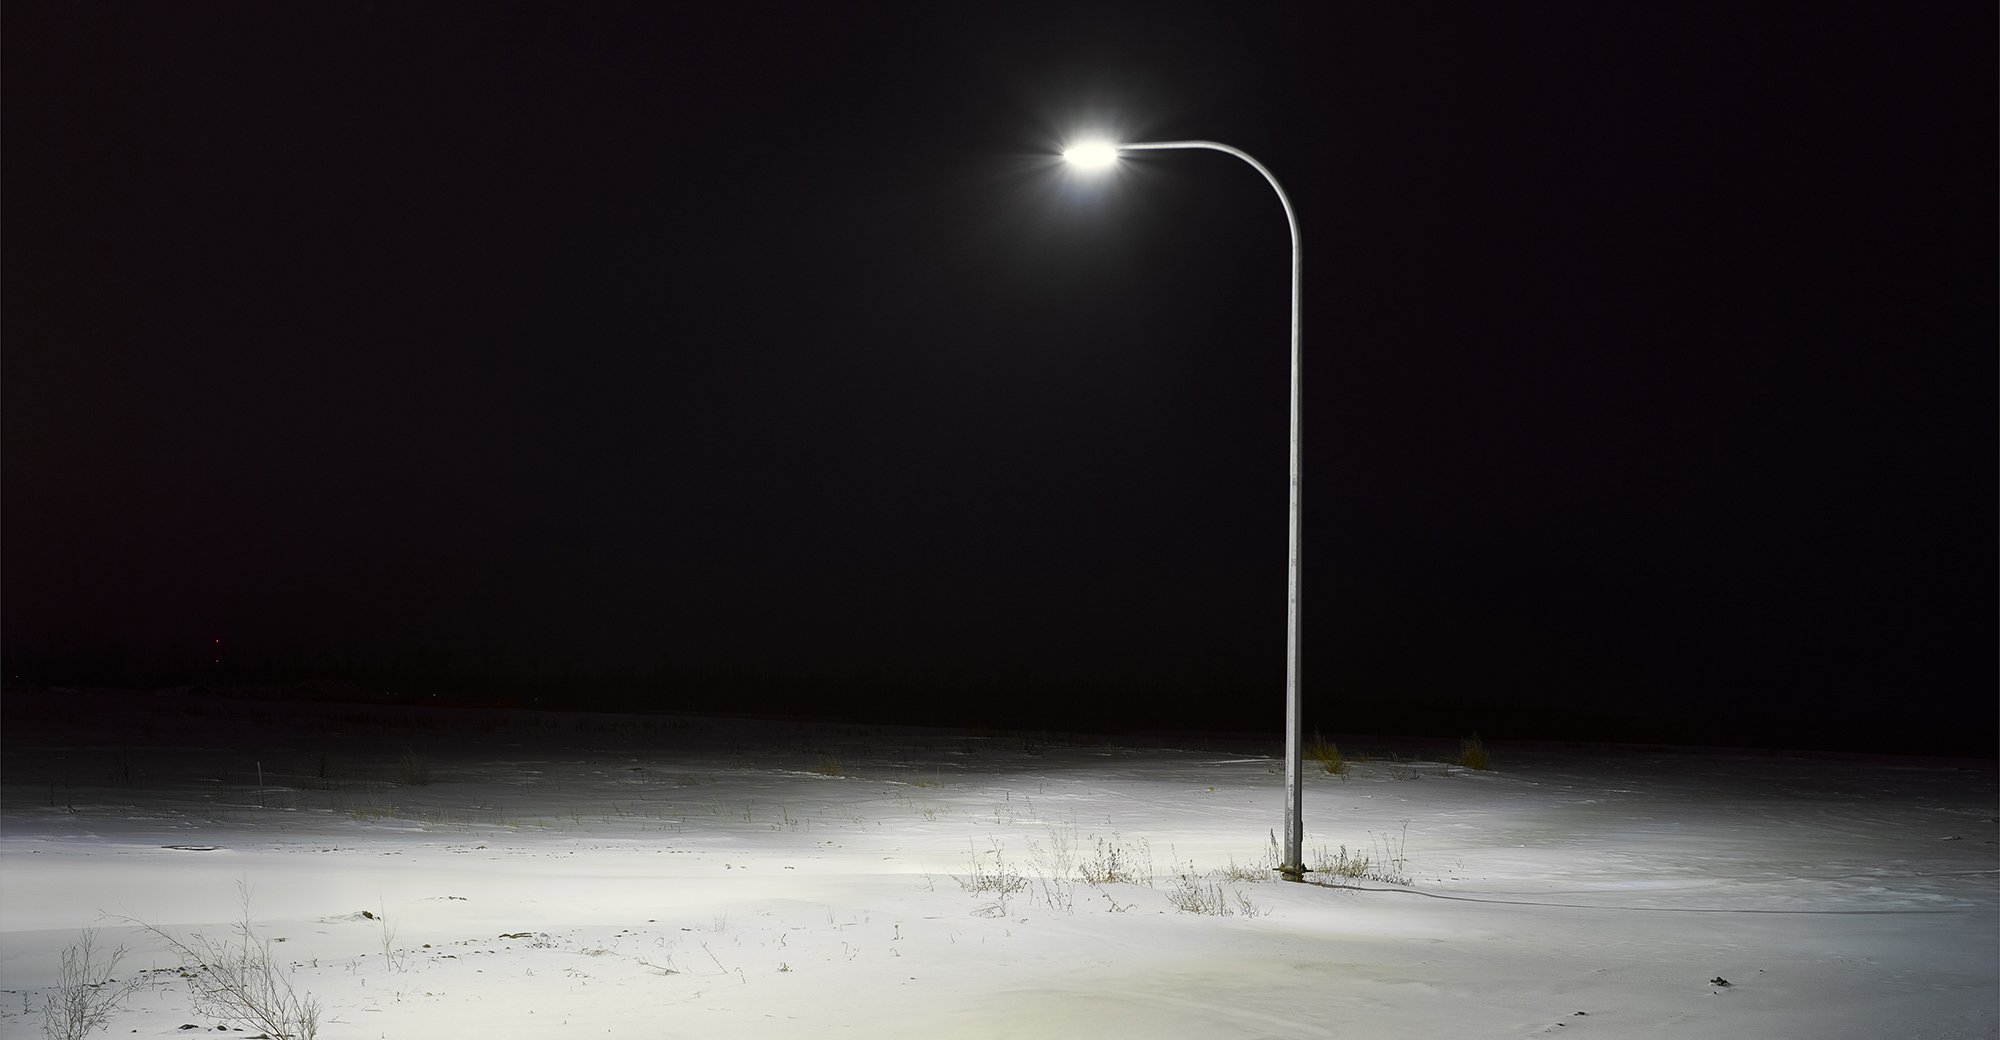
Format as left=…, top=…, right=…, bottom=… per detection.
left=0, top=690, right=2000, bottom=1040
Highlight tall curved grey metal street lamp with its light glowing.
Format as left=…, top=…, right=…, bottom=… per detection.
left=1062, top=140, right=1306, bottom=882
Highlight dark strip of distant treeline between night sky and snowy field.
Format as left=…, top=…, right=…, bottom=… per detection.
left=4, top=638, right=1996, bottom=758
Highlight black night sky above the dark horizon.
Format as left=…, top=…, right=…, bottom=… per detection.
left=0, top=0, right=2000, bottom=754
